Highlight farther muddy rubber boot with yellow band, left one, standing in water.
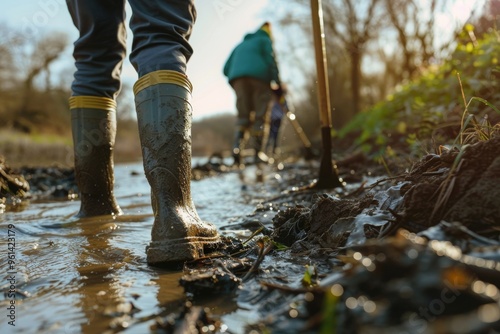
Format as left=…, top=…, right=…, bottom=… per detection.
left=70, top=96, right=122, bottom=218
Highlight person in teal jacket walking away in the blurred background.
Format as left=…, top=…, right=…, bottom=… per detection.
left=224, top=22, right=280, bottom=164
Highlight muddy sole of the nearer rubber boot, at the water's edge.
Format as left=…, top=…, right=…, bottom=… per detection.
left=146, top=236, right=220, bottom=266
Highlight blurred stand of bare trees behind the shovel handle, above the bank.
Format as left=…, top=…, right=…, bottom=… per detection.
left=273, top=0, right=482, bottom=133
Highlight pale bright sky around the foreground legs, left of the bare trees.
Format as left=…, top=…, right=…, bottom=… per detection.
left=0, top=0, right=272, bottom=120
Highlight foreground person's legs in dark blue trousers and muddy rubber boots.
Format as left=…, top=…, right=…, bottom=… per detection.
left=67, top=0, right=219, bottom=265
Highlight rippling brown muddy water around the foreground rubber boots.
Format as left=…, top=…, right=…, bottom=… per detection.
left=0, top=163, right=272, bottom=333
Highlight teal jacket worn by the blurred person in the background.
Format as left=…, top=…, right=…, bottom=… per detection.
left=224, top=29, right=280, bottom=84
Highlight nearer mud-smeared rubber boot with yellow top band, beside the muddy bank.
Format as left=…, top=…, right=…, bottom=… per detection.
left=134, top=70, right=219, bottom=265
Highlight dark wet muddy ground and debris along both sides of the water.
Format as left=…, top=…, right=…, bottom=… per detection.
left=0, top=138, right=500, bottom=333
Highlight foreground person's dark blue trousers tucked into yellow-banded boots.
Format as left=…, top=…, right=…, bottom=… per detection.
left=66, top=0, right=196, bottom=99
